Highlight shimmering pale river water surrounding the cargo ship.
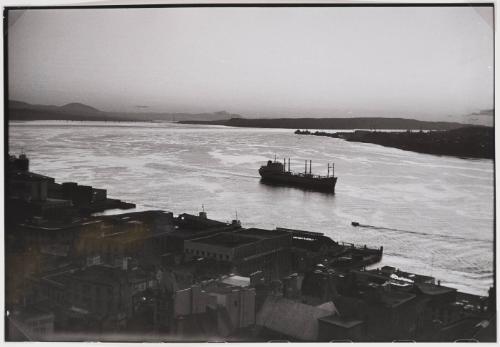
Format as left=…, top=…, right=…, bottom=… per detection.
left=9, top=121, right=494, bottom=295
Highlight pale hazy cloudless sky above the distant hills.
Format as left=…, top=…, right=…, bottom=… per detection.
left=8, top=6, right=493, bottom=120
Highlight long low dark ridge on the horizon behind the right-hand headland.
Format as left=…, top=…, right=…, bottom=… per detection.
left=179, top=117, right=472, bottom=130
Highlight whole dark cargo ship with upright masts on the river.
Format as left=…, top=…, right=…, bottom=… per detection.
left=259, top=158, right=337, bottom=193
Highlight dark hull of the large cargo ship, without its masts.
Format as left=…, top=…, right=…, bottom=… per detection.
left=259, top=170, right=337, bottom=193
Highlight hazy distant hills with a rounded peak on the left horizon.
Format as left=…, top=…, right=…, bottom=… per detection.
left=8, top=100, right=241, bottom=121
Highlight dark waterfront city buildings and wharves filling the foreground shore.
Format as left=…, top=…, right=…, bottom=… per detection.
left=5, top=157, right=496, bottom=342
